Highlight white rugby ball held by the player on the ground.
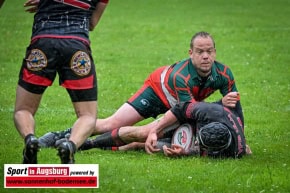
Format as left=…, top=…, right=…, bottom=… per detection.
left=171, top=123, right=194, bottom=152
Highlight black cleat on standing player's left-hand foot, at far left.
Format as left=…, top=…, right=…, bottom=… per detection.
left=22, top=135, right=38, bottom=164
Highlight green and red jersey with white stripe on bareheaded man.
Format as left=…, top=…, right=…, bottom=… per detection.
left=145, top=58, right=237, bottom=108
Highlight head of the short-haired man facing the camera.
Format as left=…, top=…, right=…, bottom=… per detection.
left=189, top=37, right=216, bottom=76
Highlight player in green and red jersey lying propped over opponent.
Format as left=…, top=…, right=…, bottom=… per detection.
left=40, top=32, right=247, bottom=151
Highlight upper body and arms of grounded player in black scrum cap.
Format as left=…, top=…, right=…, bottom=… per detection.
left=145, top=102, right=250, bottom=158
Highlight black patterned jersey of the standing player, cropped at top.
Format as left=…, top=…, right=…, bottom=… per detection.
left=32, top=0, right=99, bottom=41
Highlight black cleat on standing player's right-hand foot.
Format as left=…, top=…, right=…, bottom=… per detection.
left=57, top=141, right=76, bottom=164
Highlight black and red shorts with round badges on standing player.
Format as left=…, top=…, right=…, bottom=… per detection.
left=18, top=38, right=97, bottom=102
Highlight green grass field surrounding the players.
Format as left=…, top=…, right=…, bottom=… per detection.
left=0, top=0, right=290, bottom=193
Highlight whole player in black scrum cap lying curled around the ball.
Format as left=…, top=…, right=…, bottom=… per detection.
left=56, top=102, right=252, bottom=157
